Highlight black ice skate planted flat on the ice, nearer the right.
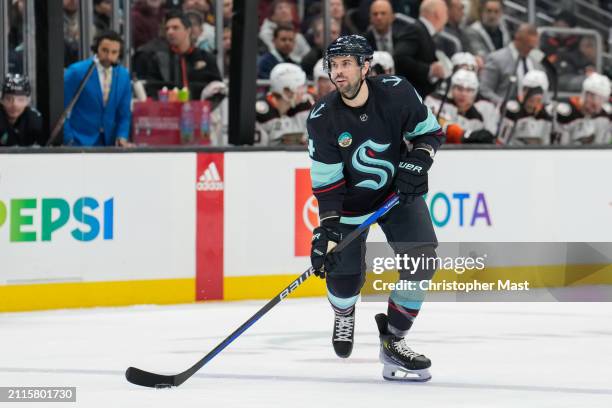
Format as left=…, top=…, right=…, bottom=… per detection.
left=376, top=313, right=431, bottom=382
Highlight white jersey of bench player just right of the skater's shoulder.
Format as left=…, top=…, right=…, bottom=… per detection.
left=425, top=94, right=499, bottom=134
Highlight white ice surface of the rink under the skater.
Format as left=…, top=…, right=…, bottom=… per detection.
left=0, top=298, right=612, bottom=408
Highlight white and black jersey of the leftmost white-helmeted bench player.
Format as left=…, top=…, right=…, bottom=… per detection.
left=255, top=94, right=313, bottom=146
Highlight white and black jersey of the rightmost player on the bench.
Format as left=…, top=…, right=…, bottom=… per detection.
left=557, top=97, right=612, bottom=145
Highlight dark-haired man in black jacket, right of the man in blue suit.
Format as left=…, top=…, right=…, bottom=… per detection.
left=134, top=10, right=221, bottom=99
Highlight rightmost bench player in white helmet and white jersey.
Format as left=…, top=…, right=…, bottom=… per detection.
left=557, top=73, right=612, bottom=145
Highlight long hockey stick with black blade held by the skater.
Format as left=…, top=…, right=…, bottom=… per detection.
left=125, top=194, right=399, bottom=388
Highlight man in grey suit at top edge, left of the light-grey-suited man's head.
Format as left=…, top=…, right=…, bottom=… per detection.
left=466, top=0, right=510, bottom=58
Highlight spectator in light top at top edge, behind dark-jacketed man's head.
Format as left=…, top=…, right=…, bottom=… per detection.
left=259, top=0, right=310, bottom=64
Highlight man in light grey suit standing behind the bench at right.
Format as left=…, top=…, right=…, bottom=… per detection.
left=480, top=24, right=542, bottom=104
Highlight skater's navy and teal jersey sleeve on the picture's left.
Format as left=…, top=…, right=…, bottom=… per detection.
left=306, top=102, right=346, bottom=214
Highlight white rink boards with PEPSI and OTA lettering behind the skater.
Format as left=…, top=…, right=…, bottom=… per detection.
left=0, top=150, right=612, bottom=311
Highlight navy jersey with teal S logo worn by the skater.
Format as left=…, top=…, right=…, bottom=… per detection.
left=306, top=75, right=443, bottom=224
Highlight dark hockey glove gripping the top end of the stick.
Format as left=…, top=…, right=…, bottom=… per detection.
left=395, top=149, right=433, bottom=204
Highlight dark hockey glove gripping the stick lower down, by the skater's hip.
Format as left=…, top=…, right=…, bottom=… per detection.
left=310, top=218, right=342, bottom=279
